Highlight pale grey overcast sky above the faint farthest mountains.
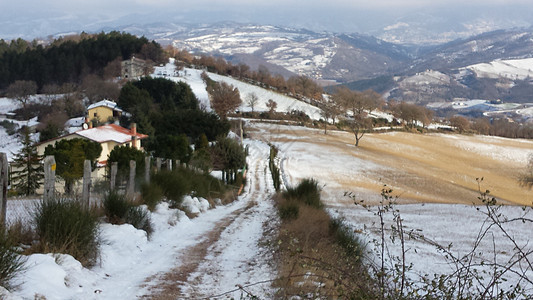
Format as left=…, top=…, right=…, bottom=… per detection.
left=4, top=0, right=533, bottom=15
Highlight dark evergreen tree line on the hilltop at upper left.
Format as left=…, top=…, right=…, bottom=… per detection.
left=0, top=31, right=165, bottom=90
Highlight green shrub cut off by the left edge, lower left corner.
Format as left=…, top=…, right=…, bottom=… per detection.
left=0, top=227, right=26, bottom=288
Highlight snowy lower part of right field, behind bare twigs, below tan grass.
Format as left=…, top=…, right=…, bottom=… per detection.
left=329, top=204, right=533, bottom=293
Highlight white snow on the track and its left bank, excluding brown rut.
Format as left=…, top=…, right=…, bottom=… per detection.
left=4, top=141, right=276, bottom=299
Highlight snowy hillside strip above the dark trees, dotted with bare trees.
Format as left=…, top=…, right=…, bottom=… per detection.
left=152, top=59, right=320, bottom=120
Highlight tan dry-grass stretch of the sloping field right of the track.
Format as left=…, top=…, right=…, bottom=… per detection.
left=249, top=126, right=533, bottom=205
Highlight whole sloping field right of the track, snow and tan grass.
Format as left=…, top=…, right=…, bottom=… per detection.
left=249, top=120, right=533, bottom=293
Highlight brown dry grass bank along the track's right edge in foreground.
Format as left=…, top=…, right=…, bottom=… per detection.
left=274, top=197, right=373, bottom=299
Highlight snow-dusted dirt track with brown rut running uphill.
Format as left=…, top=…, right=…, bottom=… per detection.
left=139, top=139, right=277, bottom=299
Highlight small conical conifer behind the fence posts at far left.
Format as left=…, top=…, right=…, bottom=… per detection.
left=11, top=127, right=44, bottom=195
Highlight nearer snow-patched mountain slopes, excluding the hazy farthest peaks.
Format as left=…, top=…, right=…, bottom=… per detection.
left=137, top=23, right=533, bottom=103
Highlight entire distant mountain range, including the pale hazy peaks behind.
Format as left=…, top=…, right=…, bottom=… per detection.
left=0, top=13, right=533, bottom=103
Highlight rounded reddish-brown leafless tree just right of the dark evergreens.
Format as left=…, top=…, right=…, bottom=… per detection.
left=207, top=82, right=242, bottom=118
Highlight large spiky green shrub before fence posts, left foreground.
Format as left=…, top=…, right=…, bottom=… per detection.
left=34, top=199, right=99, bottom=266
